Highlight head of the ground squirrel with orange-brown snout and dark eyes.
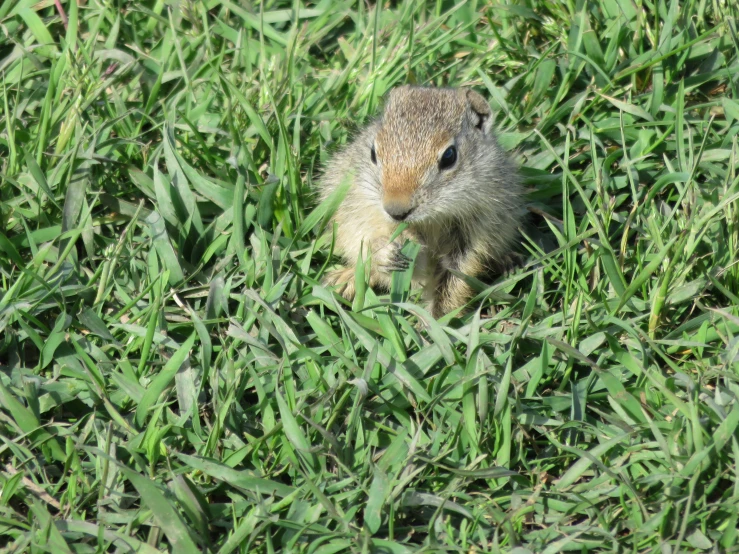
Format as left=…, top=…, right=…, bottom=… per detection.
left=367, top=86, right=497, bottom=223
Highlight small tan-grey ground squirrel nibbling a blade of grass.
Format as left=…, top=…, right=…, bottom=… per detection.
left=320, top=86, right=523, bottom=317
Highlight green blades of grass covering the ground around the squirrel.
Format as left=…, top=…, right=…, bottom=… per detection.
left=0, top=0, right=739, bottom=554
